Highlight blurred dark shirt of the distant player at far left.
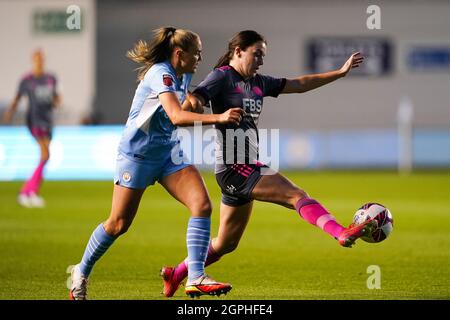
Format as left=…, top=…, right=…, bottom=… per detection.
left=18, top=74, right=57, bottom=128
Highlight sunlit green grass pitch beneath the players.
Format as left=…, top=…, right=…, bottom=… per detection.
left=0, top=171, right=450, bottom=300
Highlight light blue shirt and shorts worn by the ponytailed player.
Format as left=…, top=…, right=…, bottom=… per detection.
left=115, top=61, right=192, bottom=189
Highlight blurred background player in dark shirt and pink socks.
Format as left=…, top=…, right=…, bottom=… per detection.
left=3, top=49, right=61, bottom=208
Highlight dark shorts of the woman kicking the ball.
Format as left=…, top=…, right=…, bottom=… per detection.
left=216, top=164, right=267, bottom=207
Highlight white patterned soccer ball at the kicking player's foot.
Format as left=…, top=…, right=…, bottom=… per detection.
left=353, top=203, right=394, bottom=243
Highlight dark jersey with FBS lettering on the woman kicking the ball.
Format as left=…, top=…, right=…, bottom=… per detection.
left=194, top=66, right=286, bottom=173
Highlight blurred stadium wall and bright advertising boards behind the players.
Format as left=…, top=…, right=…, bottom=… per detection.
left=0, top=0, right=450, bottom=180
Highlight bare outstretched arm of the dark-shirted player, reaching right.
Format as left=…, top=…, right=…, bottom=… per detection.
left=281, top=52, right=364, bottom=93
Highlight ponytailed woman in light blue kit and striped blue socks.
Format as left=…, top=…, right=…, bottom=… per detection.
left=70, top=27, right=242, bottom=300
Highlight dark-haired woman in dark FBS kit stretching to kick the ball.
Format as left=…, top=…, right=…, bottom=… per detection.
left=161, top=30, right=375, bottom=297
